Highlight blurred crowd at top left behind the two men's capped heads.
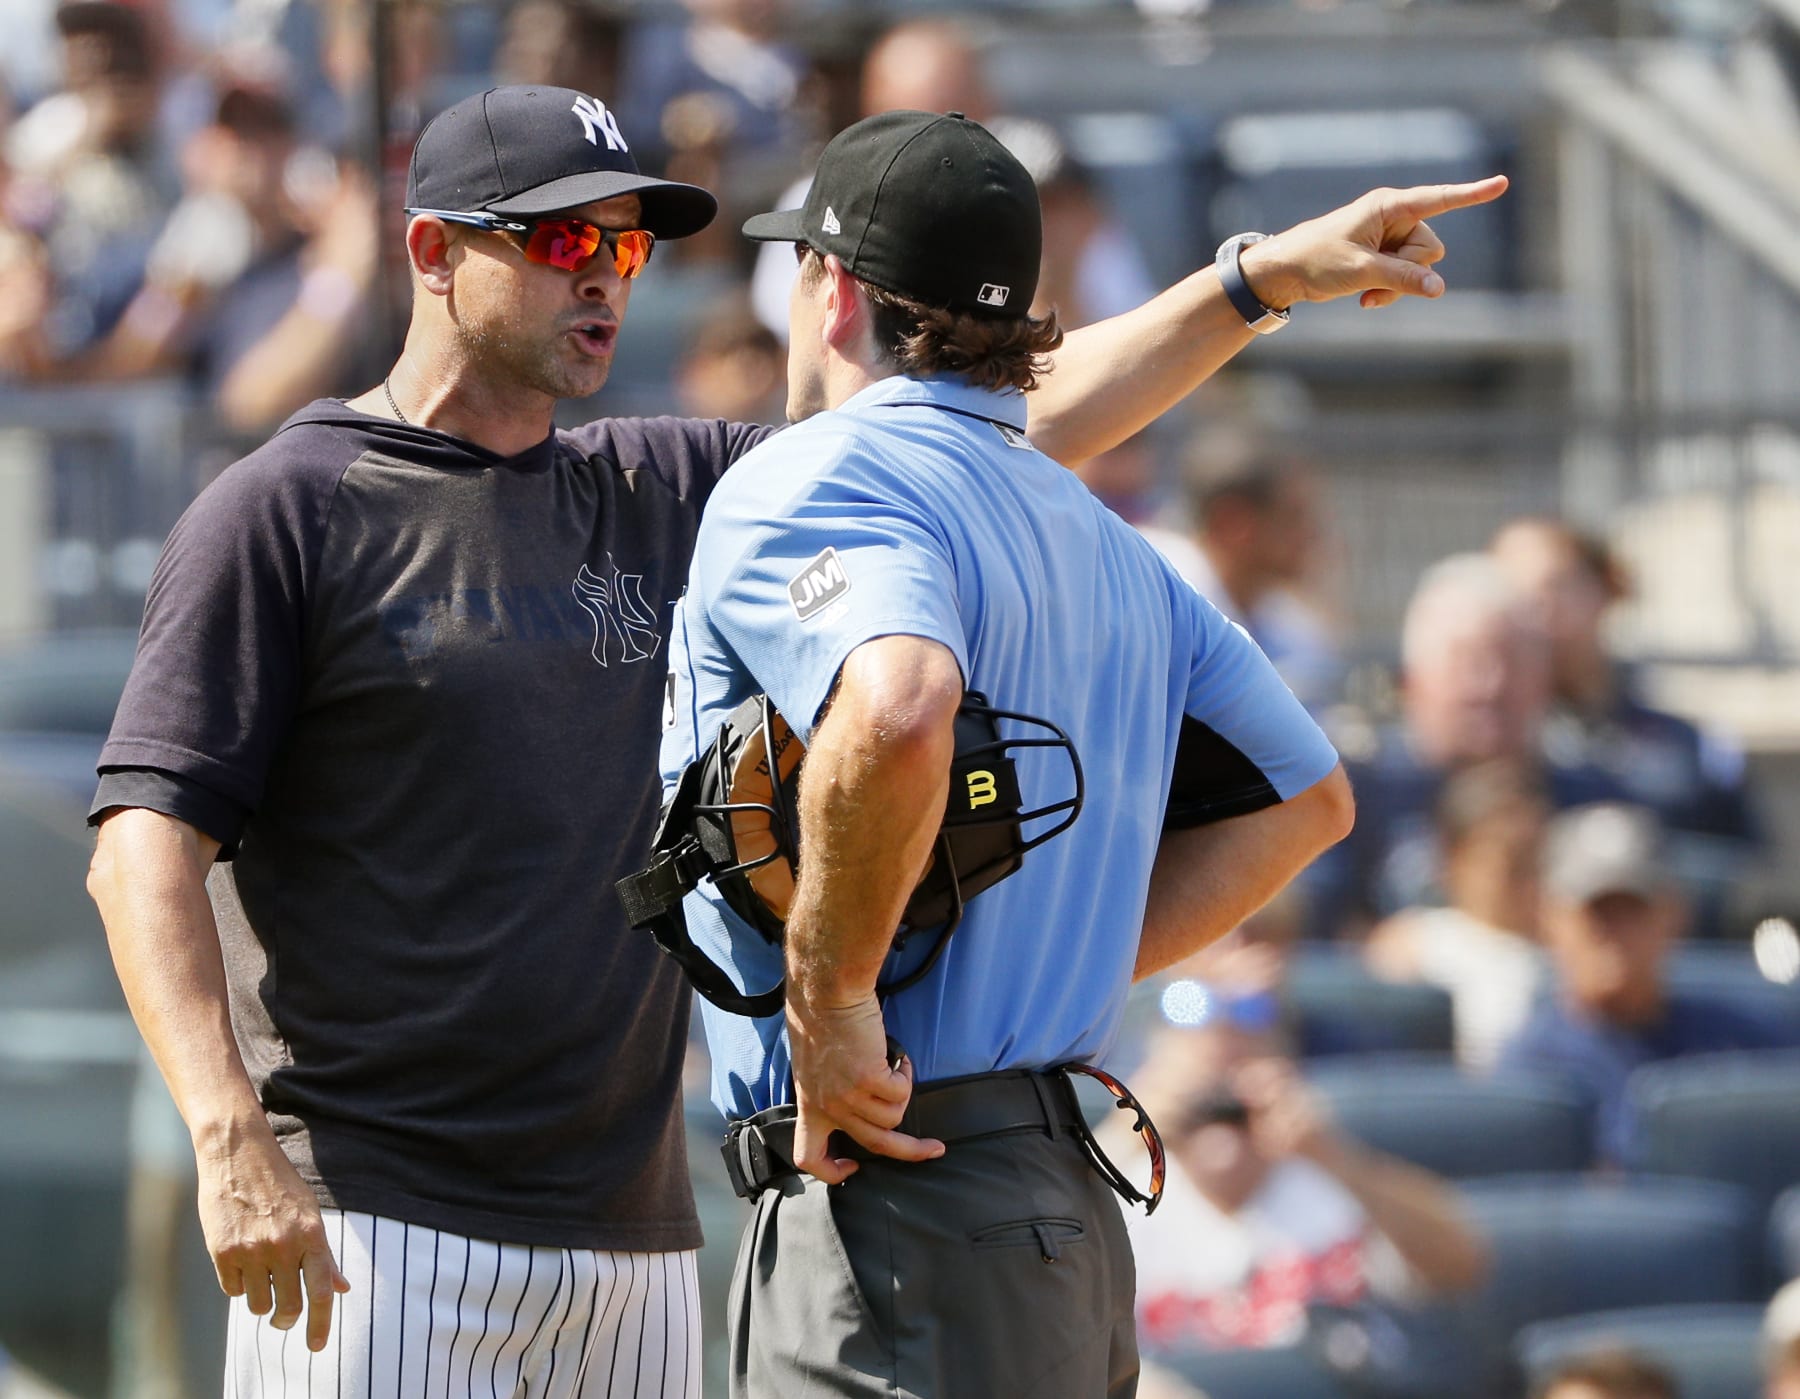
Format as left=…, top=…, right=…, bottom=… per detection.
left=0, top=0, right=1154, bottom=438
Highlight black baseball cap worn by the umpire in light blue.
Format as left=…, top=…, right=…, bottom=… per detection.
left=743, top=112, right=1044, bottom=319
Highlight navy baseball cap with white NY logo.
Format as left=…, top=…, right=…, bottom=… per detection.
left=407, top=86, right=718, bottom=238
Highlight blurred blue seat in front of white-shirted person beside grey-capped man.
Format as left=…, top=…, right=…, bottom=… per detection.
left=1307, top=1055, right=1593, bottom=1178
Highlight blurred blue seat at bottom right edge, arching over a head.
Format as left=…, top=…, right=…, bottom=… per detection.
left=1514, top=1305, right=1762, bottom=1399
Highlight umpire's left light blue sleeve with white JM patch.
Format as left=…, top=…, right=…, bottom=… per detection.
left=695, top=477, right=968, bottom=736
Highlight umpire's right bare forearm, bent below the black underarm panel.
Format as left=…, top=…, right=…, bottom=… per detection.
left=1132, top=767, right=1355, bottom=981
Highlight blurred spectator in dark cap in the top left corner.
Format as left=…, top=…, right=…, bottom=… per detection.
left=0, top=0, right=167, bottom=363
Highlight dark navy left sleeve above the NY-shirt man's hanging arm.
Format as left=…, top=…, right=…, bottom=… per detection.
left=88, top=438, right=347, bottom=848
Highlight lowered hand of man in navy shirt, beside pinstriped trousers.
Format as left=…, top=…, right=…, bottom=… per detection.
left=194, top=1116, right=349, bottom=1350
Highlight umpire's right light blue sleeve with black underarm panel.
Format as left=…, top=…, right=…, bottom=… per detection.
left=1168, top=598, right=1337, bottom=826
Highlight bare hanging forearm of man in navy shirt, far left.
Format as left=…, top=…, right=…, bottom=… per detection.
left=88, top=808, right=266, bottom=1152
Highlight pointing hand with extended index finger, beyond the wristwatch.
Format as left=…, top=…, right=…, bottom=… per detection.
left=1238, top=175, right=1507, bottom=310
